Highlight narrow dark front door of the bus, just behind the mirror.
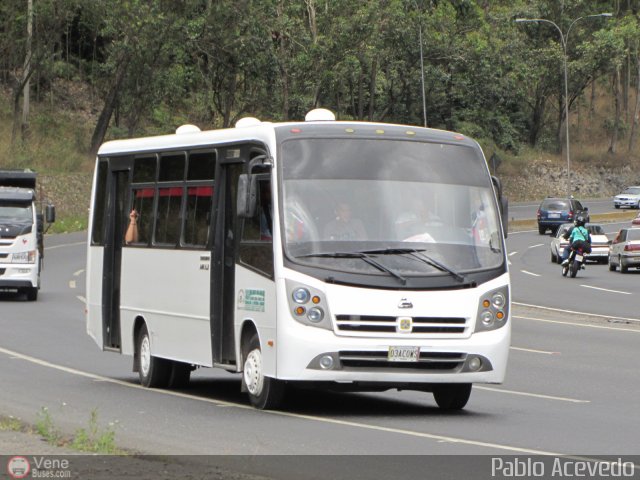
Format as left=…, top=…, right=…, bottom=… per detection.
left=210, top=158, right=244, bottom=365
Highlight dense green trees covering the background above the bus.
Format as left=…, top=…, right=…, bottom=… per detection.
left=0, top=0, right=640, bottom=221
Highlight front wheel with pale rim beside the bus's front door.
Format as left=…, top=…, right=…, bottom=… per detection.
left=242, top=333, right=284, bottom=410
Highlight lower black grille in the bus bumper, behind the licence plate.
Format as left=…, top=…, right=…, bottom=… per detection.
left=339, top=350, right=467, bottom=372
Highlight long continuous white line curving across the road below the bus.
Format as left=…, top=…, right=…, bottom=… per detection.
left=0, top=347, right=563, bottom=456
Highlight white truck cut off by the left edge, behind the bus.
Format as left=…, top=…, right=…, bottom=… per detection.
left=0, top=170, right=55, bottom=301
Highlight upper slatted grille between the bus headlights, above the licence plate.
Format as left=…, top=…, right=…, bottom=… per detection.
left=336, top=315, right=467, bottom=336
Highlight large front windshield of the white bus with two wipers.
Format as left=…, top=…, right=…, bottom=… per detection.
left=280, top=138, right=504, bottom=276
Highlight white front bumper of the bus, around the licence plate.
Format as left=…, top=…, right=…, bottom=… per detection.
left=277, top=321, right=511, bottom=389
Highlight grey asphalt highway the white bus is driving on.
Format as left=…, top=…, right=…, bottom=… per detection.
left=0, top=232, right=640, bottom=480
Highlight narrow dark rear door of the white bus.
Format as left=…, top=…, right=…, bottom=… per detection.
left=102, top=159, right=130, bottom=351
